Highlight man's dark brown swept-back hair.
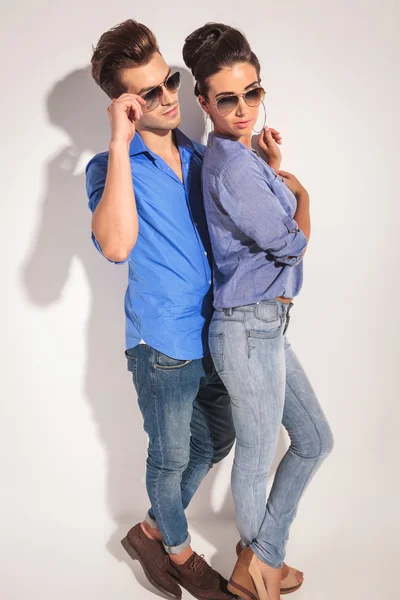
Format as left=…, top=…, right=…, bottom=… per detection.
left=91, top=19, right=160, bottom=98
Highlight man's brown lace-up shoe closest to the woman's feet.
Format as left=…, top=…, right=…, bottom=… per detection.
left=168, top=552, right=236, bottom=600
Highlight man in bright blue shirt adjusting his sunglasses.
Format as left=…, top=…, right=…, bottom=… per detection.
left=86, top=20, right=234, bottom=600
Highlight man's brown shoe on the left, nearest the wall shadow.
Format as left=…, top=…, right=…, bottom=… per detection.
left=121, top=523, right=182, bottom=600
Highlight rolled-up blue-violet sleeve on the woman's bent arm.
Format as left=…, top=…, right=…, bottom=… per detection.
left=216, top=152, right=307, bottom=266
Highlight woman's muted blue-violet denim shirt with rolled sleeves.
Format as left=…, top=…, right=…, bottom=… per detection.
left=202, top=132, right=307, bottom=308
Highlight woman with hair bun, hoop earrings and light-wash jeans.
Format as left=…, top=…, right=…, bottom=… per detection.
left=183, top=23, right=333, bottom=600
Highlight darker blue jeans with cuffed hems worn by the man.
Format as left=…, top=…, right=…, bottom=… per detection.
left=125, top=344, right=235, bottom=554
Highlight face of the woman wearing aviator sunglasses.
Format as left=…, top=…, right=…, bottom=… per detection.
left=199, top=63, right=260, bottom=145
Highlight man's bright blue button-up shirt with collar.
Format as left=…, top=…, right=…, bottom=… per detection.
left=86, top=129, right=212, bottom=360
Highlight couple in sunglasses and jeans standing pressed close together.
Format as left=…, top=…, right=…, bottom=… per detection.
left=86, top=20, right=333, bottom=600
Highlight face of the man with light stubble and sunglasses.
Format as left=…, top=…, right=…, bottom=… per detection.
left=120, top=52, right=181, bottom=131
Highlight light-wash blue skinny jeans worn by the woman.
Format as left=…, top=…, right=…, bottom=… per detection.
left=209, top=300, right=333, bottom=568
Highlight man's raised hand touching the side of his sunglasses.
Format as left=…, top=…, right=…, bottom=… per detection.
left=107, top=94, right=146, bottom=144
